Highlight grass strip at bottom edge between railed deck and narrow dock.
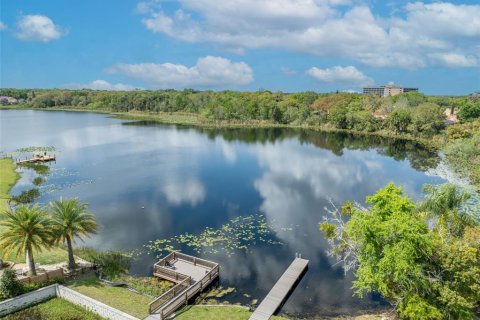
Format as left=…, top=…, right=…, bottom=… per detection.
left=174, top=305, right=287, bottom=320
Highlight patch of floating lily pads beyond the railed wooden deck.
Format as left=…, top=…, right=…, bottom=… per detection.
left=144, top=214, right=292, bottom=256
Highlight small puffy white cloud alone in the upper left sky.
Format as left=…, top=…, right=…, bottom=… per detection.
left=16, top=15, right=65, bottom=42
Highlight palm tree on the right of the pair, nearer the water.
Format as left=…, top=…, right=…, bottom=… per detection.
left=50, top=198, right=97, bottom=269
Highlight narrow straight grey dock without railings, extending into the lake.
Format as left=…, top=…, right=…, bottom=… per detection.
left=249, top=258, right=308, bottom=320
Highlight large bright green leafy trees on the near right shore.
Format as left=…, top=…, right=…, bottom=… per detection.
left=320, top=183, right=480, bottom=319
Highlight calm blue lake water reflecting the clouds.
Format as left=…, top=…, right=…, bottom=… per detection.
left=0, top=110, right=444, bottom=317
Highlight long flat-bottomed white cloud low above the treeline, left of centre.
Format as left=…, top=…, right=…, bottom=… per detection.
left=105, top=56, right=253, bottom=88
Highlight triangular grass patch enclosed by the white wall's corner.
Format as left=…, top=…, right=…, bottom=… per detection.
left=3, top=298, right=104, bottom=320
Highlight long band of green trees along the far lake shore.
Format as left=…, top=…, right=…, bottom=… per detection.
left=0, top=89, right=480, bottom=137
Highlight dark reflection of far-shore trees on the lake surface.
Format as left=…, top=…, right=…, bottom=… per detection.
left=199, top=128, right=440, bottom=171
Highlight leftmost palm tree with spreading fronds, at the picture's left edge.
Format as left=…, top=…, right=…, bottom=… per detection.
left=0, top=204, right=52, bottom=275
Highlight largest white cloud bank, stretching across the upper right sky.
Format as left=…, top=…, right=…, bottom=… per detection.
left=140, top=0, right=480, bottom=69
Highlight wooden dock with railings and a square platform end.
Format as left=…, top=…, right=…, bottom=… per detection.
left=145, top=252, right=220, bottom=320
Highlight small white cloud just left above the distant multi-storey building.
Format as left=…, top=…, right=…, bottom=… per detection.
left=306, top=66, right=373, bottom=86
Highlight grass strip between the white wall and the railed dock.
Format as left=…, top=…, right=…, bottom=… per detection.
left=66, top=273, right=152, bottom=319
